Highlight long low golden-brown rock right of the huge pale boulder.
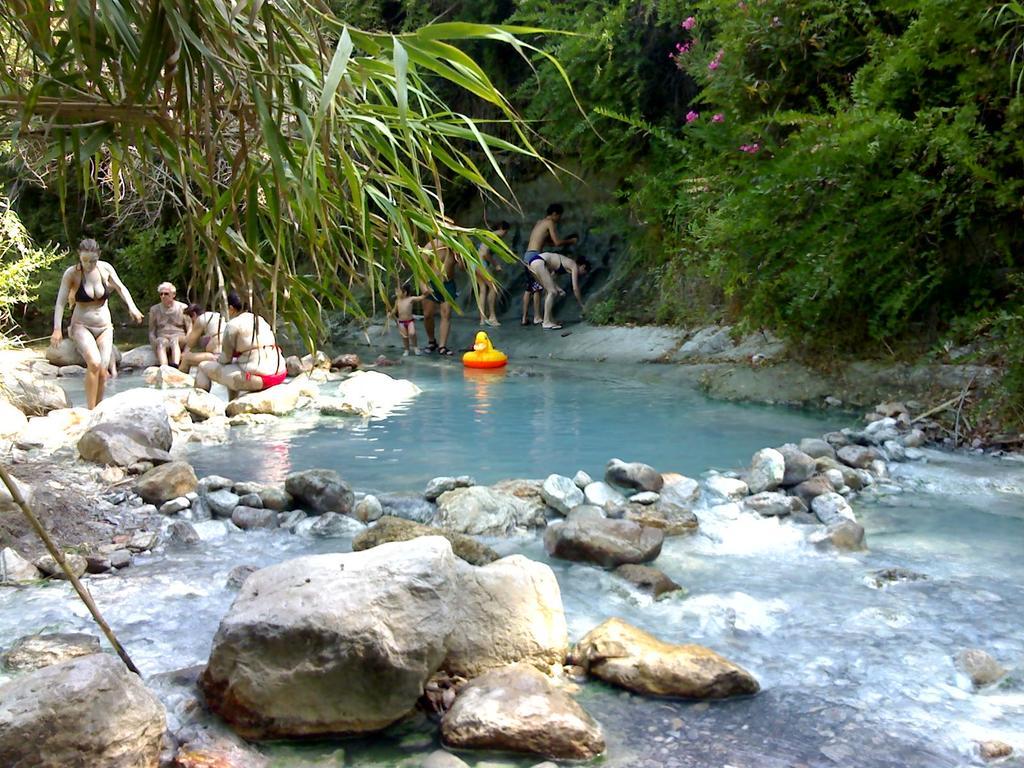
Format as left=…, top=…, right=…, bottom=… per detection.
left=572, top=618, right=761, bottom=698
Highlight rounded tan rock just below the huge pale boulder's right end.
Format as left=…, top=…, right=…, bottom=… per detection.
left=441, top=665, right=604, bottom=760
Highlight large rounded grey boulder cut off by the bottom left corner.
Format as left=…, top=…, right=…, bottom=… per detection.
left=0, top=653, right=167, bottom=768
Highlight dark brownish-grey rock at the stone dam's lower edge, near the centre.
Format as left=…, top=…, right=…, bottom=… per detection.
left=544, top=518, right=665, bottom=568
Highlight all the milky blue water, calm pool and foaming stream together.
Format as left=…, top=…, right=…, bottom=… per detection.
left=0, top=360, right=1024, bottom=768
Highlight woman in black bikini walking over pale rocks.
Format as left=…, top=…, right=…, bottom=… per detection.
left=50, top=240, right=143, bottom=409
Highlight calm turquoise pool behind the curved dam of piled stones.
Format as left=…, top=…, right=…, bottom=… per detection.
left=182, top=360, right=849, bottom=490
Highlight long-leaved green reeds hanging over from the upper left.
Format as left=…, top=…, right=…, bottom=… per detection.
left=0, top=0, right=569, bottom=342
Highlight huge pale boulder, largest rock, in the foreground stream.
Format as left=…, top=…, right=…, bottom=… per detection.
left=200, top=537, right=567, bottom=738
